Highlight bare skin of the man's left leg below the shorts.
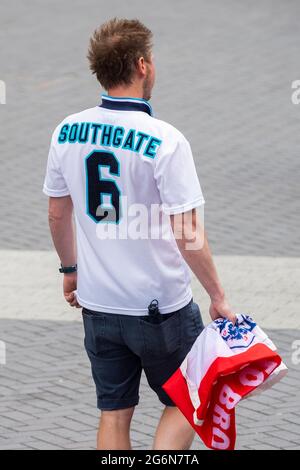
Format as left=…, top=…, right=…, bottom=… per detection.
left=97, top=407, right=134, bottom=450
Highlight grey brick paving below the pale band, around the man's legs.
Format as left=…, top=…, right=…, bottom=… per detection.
left=0, top=319, right=300, bottom=450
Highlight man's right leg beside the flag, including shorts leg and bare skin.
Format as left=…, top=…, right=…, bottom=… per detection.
left=141, top=301, right=203, bottom=450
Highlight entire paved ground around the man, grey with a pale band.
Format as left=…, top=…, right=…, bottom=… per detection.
left=0, top=0, right=300, bottom=449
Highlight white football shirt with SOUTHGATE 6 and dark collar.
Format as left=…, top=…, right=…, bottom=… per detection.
left=43, top=95, right=204, bottom=315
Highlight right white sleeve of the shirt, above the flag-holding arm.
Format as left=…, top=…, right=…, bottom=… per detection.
left=154, top=134, right=205, bottom=215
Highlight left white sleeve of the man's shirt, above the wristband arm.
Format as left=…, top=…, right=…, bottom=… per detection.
left=43, top=138, right=70, bottom=197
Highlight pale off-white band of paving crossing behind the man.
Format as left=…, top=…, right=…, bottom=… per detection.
left=0, top=250, right=300, bottom=330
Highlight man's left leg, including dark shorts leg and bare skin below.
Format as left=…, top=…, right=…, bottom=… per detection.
left=82, top=309, right=142, bottom=450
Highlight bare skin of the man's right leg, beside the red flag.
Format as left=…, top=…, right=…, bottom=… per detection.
left=153, top=406, right=195, bottom=450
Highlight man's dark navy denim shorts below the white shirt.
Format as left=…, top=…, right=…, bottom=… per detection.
left=82, top=300, right=203, bottom=410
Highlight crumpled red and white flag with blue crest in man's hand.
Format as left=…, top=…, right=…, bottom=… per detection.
left=163, top=315, right=287, bottom=450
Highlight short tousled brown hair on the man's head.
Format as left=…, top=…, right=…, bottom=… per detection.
left=87, top=18, right=153, bottom=90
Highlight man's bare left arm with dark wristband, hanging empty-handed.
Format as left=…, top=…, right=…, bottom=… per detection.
left=48, top=196, right=80, bottom=307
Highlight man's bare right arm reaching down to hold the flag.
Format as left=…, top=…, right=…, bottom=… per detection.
left=170, top=209, right=236, bottom=323
